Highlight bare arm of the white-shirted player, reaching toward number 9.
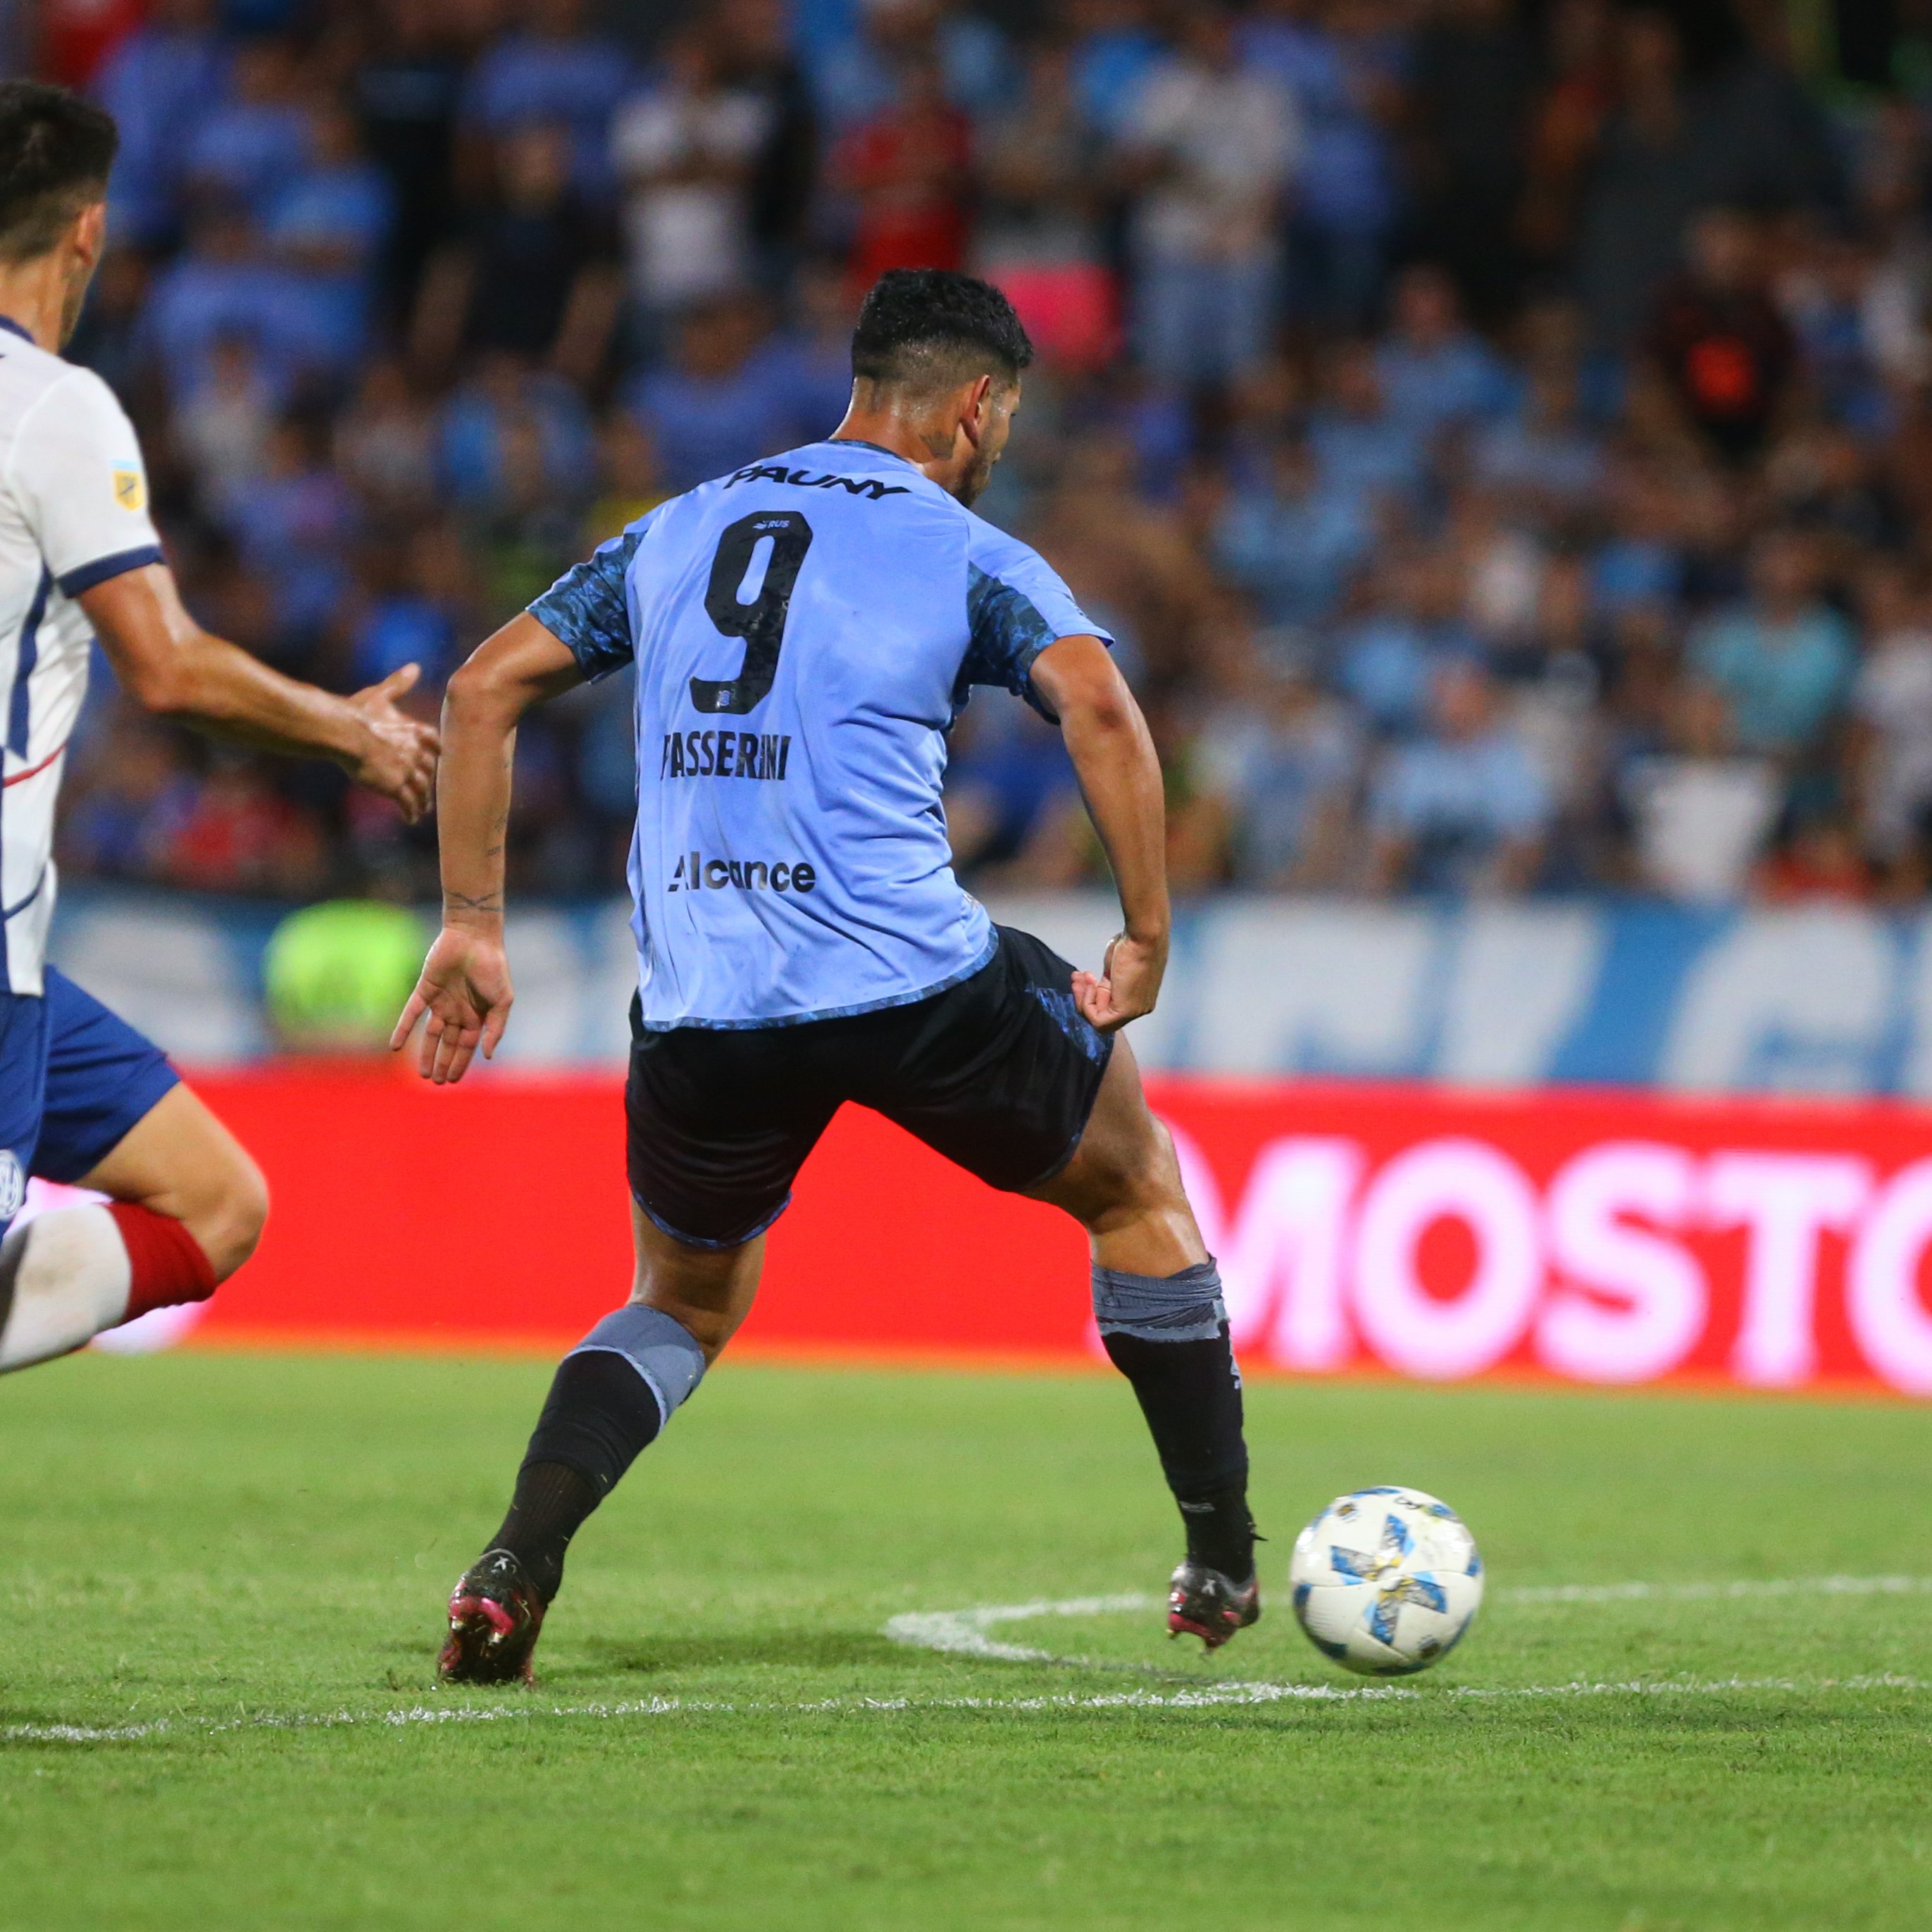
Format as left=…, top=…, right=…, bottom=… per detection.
left=79, top=564, right=437, bottom=825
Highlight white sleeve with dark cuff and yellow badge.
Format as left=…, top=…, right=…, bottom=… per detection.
left=8, top=369, right=162, bottom=597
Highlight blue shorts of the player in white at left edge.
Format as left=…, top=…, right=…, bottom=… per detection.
left=0, top=966, right=182, bottom=1233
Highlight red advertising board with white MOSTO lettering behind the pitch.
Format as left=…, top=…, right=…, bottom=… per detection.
left=64, top=1068, right=1932, bottom=1395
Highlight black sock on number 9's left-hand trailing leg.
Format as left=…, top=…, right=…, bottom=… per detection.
left=489, top=1349, right=663, bottom=1604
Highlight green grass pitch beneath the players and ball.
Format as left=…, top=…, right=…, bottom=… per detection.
left=0, top=1354, right=1932, bottom=1932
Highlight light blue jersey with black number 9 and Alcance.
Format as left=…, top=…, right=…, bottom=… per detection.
left=530, top=442, right=1113, bottom=1032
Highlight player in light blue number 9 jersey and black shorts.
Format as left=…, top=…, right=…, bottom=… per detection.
left=396, top=270, right=1259, bottom=1683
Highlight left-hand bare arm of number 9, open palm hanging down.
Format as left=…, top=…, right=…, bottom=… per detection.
left=390, top=611, right=583, bottom=1086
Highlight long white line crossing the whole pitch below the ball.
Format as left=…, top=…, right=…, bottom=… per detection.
left=0, top=1671, right=1932, bottom=1745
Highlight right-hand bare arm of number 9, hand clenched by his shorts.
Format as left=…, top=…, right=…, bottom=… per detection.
left=1032, top=637, right=1171, bottom=1034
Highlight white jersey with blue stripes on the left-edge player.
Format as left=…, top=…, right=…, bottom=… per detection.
left=0, top=317, right=161, bottom=993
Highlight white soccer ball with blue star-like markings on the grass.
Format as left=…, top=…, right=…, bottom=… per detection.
left=1289, top=1488, right=1482, bottom=1677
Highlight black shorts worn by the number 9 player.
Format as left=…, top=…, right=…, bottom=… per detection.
left=624, top=926, right=1113, bottom=1248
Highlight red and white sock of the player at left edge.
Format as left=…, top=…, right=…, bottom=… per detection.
left=0, top=1202, right=214, bottom=1373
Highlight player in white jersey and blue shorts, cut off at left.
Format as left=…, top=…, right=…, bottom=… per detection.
left=0, top=81, right=437, bottom=1370
